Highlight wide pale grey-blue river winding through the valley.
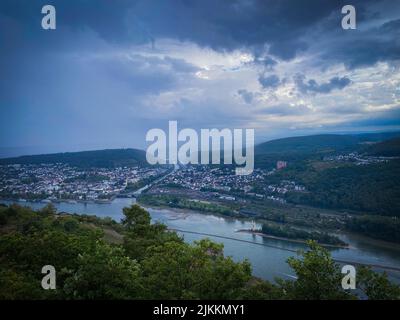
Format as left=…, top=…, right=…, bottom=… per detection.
left=4, top=198, right=400, bottom=283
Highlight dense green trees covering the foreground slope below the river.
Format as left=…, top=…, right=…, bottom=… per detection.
left=0, top=205, right=400, bottom=300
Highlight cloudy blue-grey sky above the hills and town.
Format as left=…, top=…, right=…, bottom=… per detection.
left=0, top=0, right=400, bottom=157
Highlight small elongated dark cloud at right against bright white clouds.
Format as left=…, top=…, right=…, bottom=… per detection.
left=294, top=74, right=351, bottom=93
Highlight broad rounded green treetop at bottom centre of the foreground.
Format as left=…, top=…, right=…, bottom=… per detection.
left=142, top=239, right=251, bottom=299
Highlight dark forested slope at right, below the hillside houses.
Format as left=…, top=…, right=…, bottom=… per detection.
left=283, top=160, right=400, bottom=216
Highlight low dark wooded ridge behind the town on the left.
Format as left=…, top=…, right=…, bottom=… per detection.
left=0, top=149, right=147, bottom=168
